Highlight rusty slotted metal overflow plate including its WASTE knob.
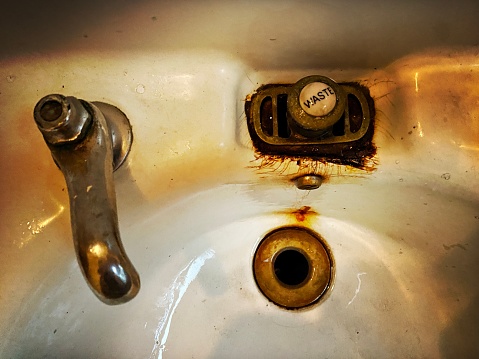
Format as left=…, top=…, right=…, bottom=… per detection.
left=245, top=75, right=376, bottom=169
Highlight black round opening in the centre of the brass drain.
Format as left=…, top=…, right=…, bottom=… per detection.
left=274, top=249, right=309, bottom=286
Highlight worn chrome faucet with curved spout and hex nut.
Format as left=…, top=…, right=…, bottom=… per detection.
left=34, top=94, right=140, bottom=305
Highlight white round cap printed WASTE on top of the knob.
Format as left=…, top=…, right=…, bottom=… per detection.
left=299, top=82, right=336, bottom=116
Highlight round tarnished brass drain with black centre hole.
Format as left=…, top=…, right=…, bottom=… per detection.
left=253, top=227, right=333, bottom=309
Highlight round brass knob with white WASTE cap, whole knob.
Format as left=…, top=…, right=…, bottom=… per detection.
left=288, top=76, right=346, bottom=138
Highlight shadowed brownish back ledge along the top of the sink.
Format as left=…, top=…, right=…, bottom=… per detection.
left=0, top=0, right=479, bottom=69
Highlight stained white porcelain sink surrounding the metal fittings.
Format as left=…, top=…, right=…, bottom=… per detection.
left=0, top=1, right=479, bottom=358
